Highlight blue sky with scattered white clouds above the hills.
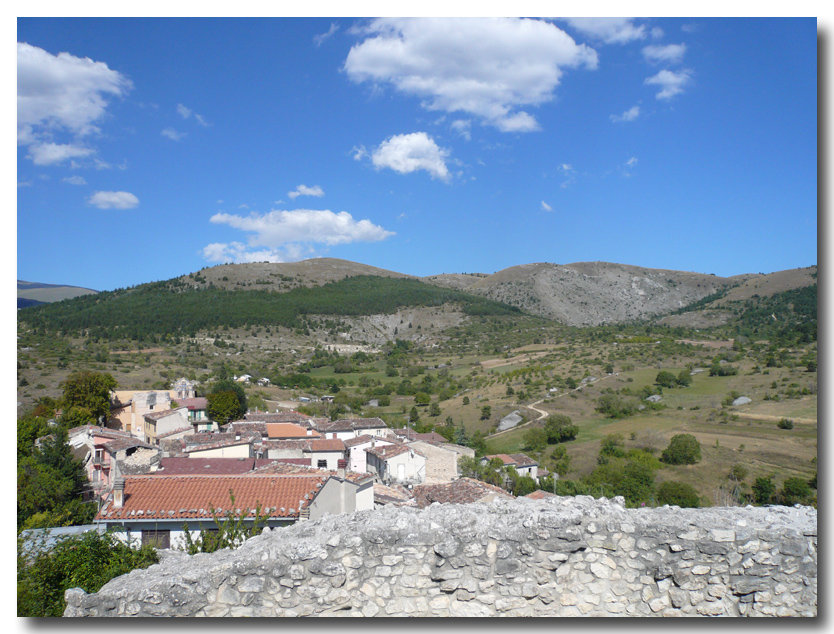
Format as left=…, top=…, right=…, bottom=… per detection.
left=16, top=18, right=817, bottom=290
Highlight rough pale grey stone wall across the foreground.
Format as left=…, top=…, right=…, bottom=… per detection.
left=64, top=496, right=817, bottom=616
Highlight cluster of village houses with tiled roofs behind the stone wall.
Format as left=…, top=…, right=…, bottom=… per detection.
left=61, top=379, right=538, bottom=548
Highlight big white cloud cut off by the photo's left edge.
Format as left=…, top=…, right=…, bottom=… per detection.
left=17, top=42, right=133, bottom=165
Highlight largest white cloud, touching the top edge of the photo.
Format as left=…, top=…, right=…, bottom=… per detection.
left=344, top=18, right=597, bottom=132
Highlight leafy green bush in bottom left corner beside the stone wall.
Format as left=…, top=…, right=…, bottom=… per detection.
left=17, top=531, right=159, bottom=617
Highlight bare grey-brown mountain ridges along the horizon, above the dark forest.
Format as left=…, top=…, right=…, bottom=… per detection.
left=18, top=258, right=817, bottom=327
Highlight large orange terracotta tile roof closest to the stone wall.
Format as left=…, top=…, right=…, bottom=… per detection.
left=95, top=474, right=327, bottom=521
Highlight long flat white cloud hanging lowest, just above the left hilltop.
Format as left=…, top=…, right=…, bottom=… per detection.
left=203, top=209, right=394, bottom=263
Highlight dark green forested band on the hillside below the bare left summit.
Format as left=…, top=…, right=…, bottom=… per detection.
left=19, top=276, right=521, bottom=340
